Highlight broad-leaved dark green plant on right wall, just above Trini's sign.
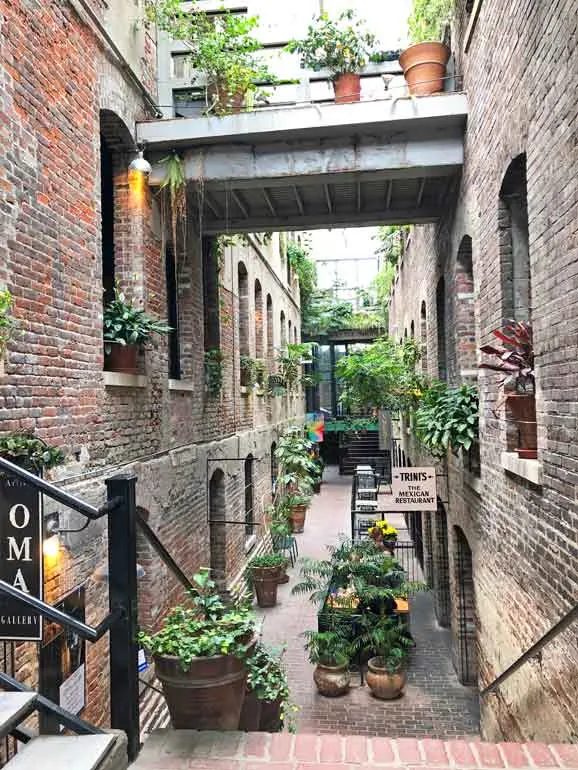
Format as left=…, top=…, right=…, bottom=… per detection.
left=415, top=382, right=479, bottom=457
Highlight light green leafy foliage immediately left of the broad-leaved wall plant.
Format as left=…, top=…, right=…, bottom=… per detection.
left=336, top=337, right=423, bottom=412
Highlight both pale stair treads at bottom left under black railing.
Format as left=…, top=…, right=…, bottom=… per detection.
left=0, top=680, right=128, bottom=770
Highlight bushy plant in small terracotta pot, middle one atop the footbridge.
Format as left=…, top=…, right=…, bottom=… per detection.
left=287, top=10, right=375, bottom=103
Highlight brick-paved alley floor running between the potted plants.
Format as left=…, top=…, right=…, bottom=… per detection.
left=263, top=468, right=479, bottom=738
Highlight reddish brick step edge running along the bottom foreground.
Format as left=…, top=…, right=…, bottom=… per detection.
left=131, top=729, right=578, bottom=770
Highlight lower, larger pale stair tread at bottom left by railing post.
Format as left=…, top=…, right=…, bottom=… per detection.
left=5, top=734, right=127, bottom=770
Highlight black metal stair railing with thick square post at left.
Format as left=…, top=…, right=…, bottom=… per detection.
left=0, top=458, right=140, bottom=762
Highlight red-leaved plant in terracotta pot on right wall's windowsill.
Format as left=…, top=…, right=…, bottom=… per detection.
left=480, top=321, right=538, bottom=460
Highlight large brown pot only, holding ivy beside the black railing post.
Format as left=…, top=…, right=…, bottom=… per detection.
left=154, top=655, right=247, bottom=730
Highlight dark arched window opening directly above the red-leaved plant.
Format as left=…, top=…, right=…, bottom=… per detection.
left=498, top=153, right=532, bottom=321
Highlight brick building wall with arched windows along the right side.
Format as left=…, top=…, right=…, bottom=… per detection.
left=390, top=0, right=578, bottom=741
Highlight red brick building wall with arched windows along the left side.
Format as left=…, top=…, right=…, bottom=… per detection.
left=0, top=0, right=303, bottom=726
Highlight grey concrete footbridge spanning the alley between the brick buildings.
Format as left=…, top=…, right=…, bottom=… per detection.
left=137, top=93, right=467, bottom=234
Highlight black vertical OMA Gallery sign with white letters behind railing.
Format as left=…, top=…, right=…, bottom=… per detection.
left=0, top=473, right=44, bottom=641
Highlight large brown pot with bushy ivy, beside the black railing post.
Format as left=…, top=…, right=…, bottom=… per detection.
left=139, top=570, right=255, bottom=730
